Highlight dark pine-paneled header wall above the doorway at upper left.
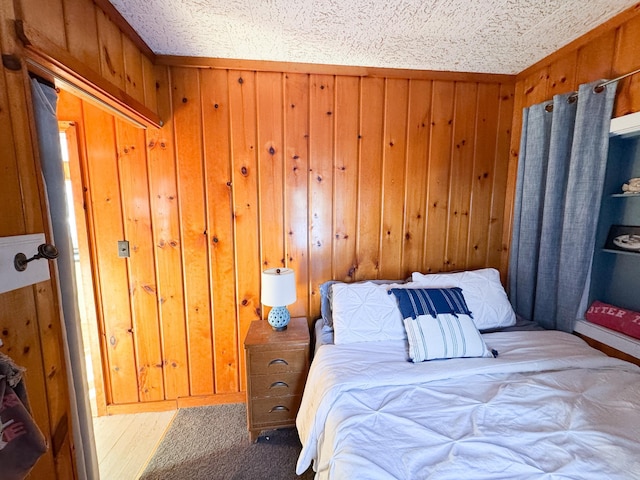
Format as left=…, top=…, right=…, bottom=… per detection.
left=13, top=0, right=156, bottom=121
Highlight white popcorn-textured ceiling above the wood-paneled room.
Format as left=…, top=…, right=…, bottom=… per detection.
left=110, top=0, right=636, bottom=74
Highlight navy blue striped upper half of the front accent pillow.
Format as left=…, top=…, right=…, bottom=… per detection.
left=389, top=287, right=473, bottom=319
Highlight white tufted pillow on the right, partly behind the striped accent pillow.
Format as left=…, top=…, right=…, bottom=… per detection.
left=411, top=268, right=516, bottom=330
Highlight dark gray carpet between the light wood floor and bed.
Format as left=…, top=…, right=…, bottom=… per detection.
left=140, top=403, right=313, bottom=480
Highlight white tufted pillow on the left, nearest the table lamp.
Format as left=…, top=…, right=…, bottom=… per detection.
left=331, top=282, right=407, bottom=345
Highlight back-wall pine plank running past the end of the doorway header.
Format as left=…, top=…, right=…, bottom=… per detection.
left=147, top=67, right=189, bottom=400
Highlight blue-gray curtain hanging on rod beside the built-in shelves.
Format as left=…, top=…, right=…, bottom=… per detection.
left=509, top=81, right=617, bottom=332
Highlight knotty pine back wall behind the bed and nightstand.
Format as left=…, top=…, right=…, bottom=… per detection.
left=58, top=66, right=513, bottom=411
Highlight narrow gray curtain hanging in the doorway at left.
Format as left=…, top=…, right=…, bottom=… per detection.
left=31, top=79, right=99, bottom=480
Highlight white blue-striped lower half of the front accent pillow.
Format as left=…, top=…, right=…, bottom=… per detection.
left=404, top=313, right=493, bottom=363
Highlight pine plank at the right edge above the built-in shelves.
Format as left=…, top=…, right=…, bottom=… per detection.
left=611, top=16, right=640, bottom=117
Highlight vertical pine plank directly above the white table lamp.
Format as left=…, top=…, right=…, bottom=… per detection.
left=256, top=72, right=287, bottom=274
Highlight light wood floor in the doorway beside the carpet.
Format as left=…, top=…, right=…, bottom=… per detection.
left=93, top=411, right=176, bottom=480
